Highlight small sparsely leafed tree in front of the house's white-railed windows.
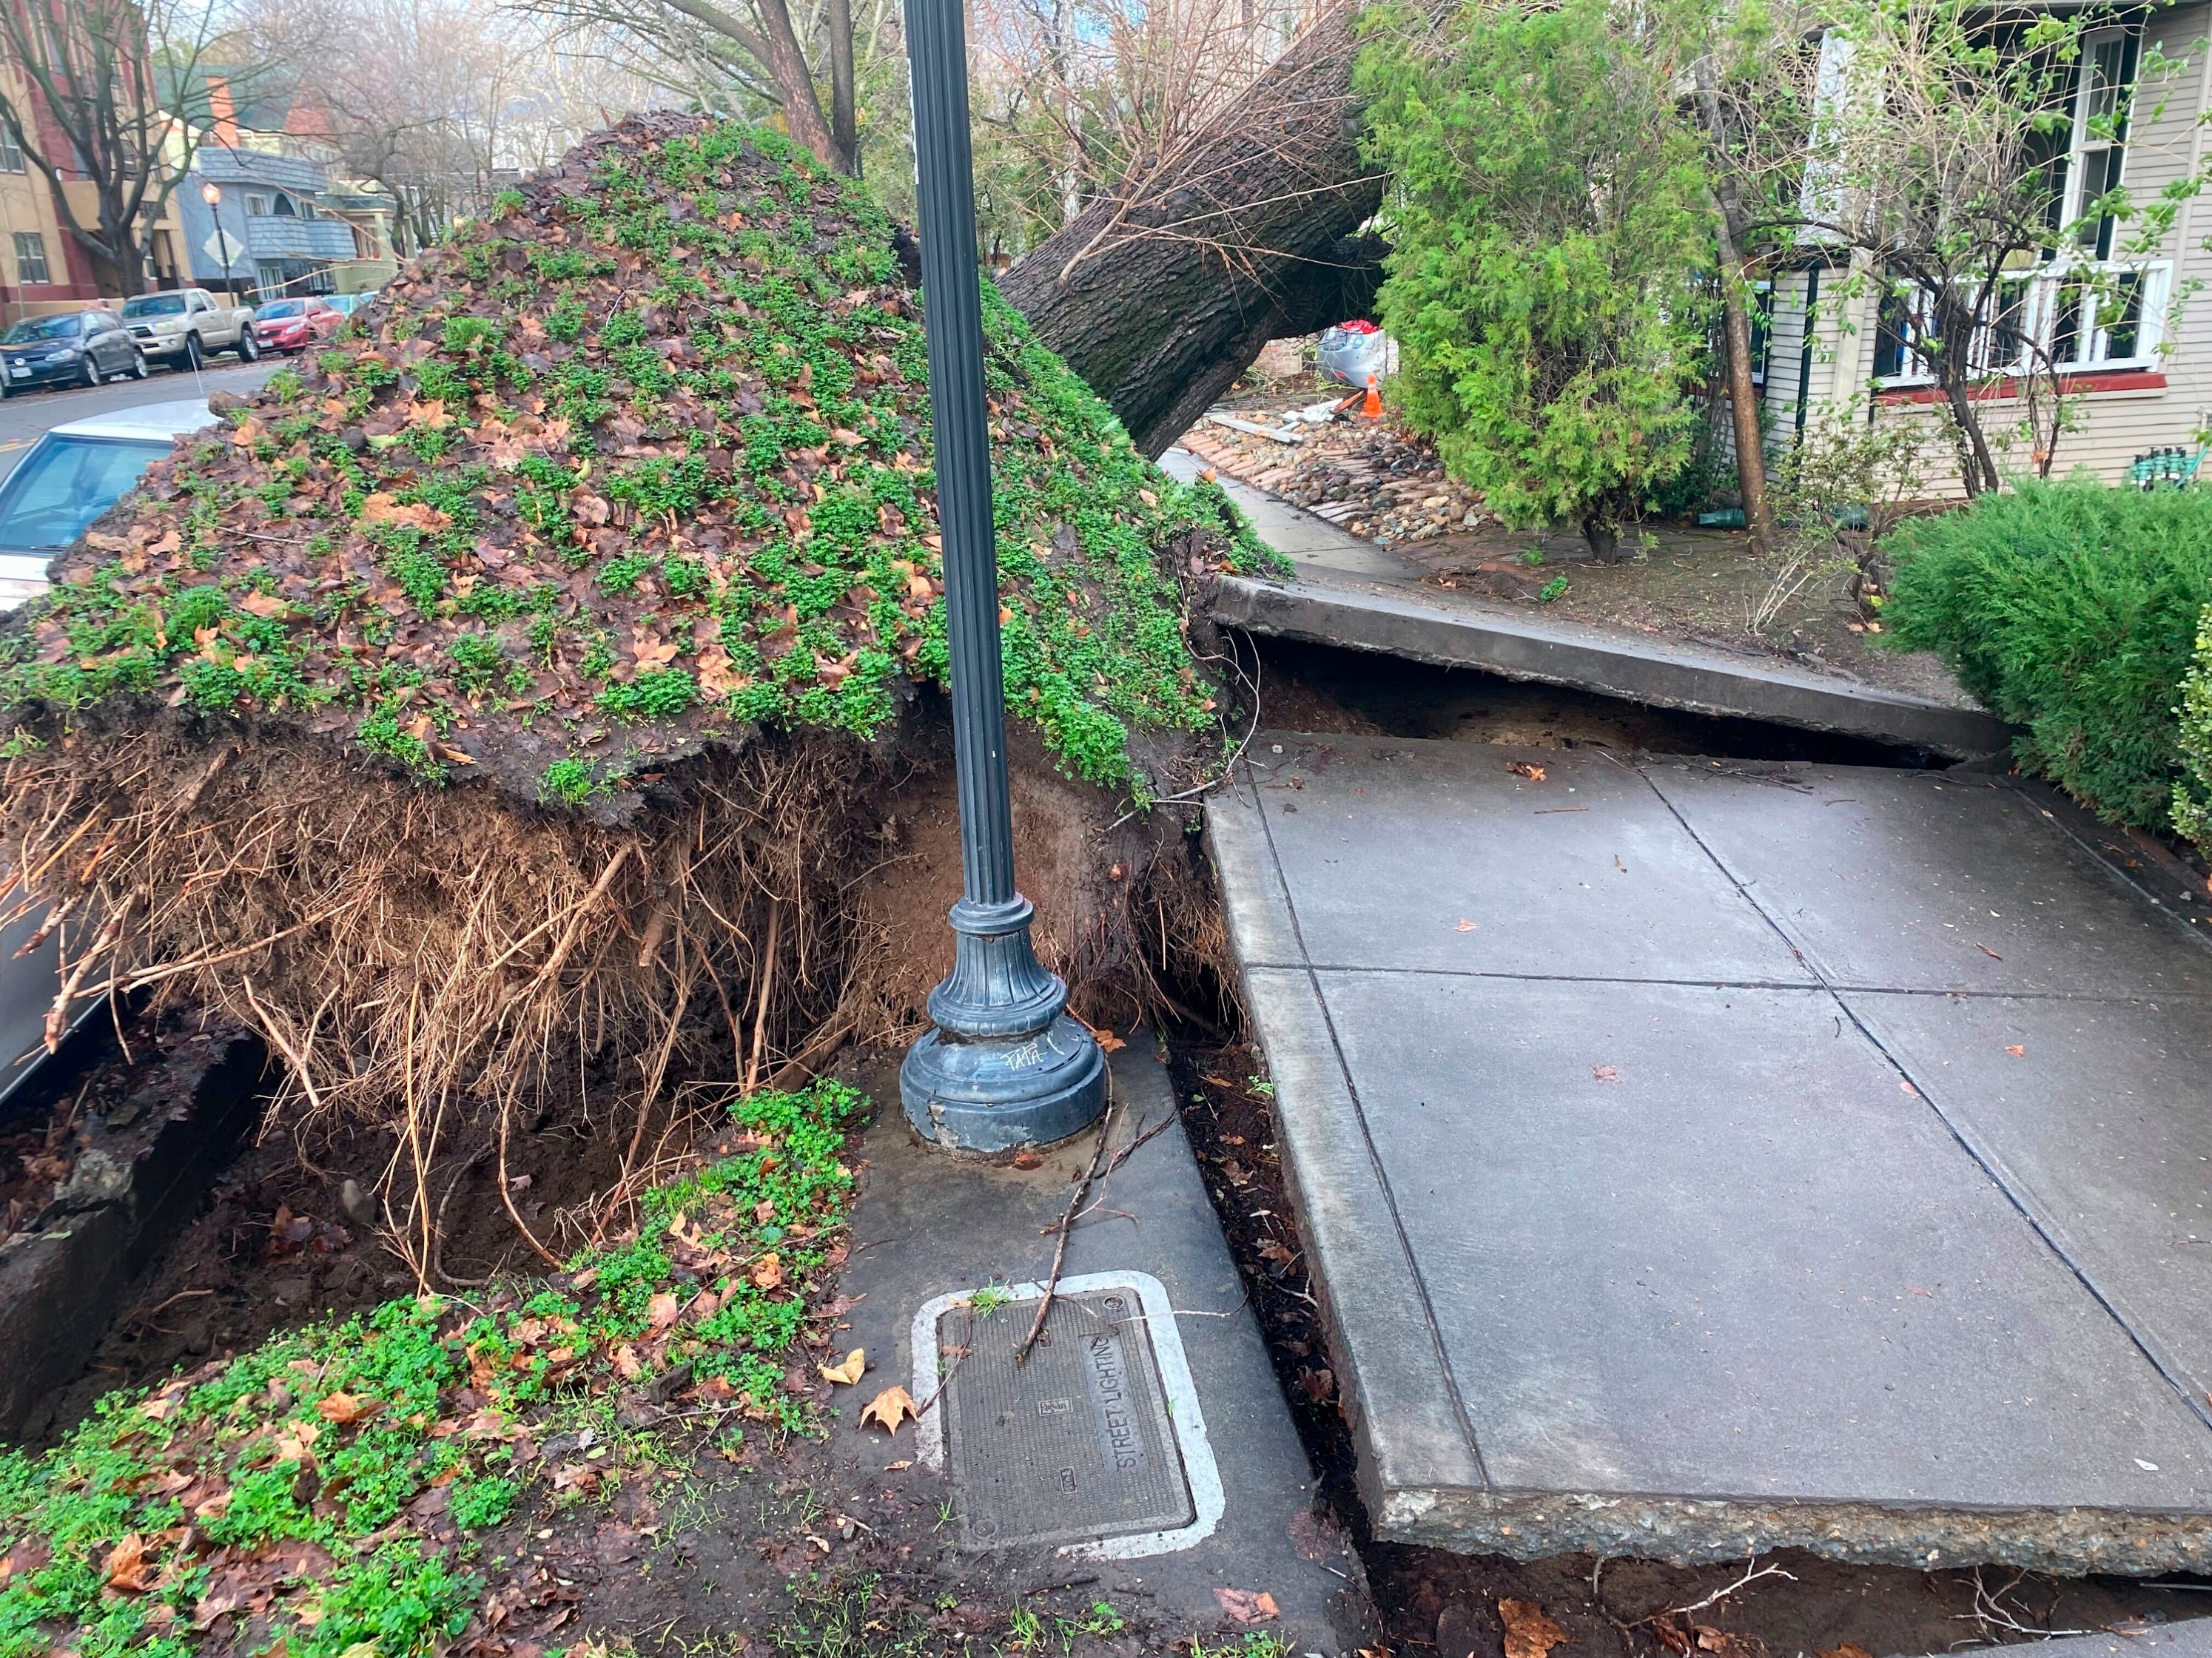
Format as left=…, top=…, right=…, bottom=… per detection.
left=1718, top=0, right=2205, bottom=495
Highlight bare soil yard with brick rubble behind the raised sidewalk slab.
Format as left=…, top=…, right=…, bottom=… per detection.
left=1183, top=395, right=1969, bottom=721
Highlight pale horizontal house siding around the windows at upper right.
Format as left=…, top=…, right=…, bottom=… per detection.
left=1765, top=4, right=2212, bottom=495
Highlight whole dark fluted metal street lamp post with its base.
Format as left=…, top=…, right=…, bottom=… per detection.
left=898, top=0, right=1106, bottom=1152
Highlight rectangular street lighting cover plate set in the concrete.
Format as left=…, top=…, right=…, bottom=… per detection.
left=938, top=1289, right=1197, bottom=1550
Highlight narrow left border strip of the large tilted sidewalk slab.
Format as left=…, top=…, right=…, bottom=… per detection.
left=1206, top=774, right=1482, bottom=1514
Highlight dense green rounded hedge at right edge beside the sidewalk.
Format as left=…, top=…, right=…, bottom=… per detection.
left=1883, top=479, right=2212, bottom=829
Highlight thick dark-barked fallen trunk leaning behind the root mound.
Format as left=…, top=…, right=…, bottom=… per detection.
left=1000, top=4, right=1382, bottom=456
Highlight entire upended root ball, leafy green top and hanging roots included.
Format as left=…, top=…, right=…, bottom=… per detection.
left=0, top=117, right=1268, bottom=1280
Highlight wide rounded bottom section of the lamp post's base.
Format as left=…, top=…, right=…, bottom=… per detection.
left=898, top=1013, right=1106, bottom=1156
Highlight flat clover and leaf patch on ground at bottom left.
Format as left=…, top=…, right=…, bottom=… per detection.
left=0, top=1081, right=865, bottom=1658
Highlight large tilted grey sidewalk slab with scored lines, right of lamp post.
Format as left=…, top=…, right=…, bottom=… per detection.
left=1208, top=734, right=2212, bottom=1571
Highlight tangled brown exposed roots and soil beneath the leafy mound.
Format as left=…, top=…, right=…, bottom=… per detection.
left=0, top=716, right=1221, bottom=1287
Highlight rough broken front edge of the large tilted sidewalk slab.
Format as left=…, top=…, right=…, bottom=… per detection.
left=1371, top=1486, right=2212, bottom=1576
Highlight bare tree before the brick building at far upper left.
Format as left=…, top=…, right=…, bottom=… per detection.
left=0, top=0, right=252, bottom=296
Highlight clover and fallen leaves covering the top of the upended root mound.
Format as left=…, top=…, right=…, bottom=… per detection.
left=0, top=119, right=1272, bottom=803
